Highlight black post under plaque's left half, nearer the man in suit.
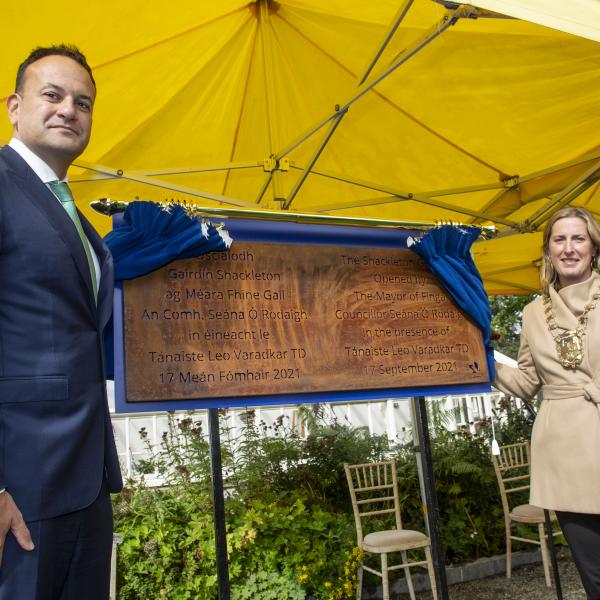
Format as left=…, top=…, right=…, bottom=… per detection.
left=208, top=408, right=230, bottom=600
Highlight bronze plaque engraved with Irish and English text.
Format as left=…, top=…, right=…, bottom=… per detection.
left=124, top=242, right=488, bottom=402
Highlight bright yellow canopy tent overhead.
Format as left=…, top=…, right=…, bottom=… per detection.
left=0, top=0, right=600, bottom=293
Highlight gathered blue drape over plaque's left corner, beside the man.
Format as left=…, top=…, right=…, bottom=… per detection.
left=104, top=201, right=232, bottom=376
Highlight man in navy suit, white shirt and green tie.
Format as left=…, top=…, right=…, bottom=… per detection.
left=0, top=45, right=122, bottom=600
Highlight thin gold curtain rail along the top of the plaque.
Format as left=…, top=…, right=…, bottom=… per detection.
left=90, top=198, right=496, bottom=239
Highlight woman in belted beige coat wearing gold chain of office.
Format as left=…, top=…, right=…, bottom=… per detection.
left=495, top=207, right=600, bottom=600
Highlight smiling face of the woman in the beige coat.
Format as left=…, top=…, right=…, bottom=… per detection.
left=548, top=217, right=598, bottom=287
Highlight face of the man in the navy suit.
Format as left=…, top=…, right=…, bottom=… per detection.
left=7, top=56, right=96, bottom=177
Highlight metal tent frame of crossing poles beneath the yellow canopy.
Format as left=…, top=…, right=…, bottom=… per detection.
left=72, top=0, right=600, bottom=258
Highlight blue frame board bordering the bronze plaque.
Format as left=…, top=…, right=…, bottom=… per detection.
left=113, top=214, right=491, bottom=414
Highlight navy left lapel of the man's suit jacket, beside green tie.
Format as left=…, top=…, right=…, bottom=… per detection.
left=0, top=146, right=95, bottom=311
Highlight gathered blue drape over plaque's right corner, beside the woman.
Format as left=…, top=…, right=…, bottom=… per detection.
left=411, top=225, right=494, bottom=381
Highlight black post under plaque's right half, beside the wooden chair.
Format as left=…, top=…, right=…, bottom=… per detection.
left=411, top=396, right=449, bottom=600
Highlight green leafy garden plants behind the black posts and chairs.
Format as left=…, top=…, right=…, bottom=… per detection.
left=114, top=400, right=529, bottom=600
